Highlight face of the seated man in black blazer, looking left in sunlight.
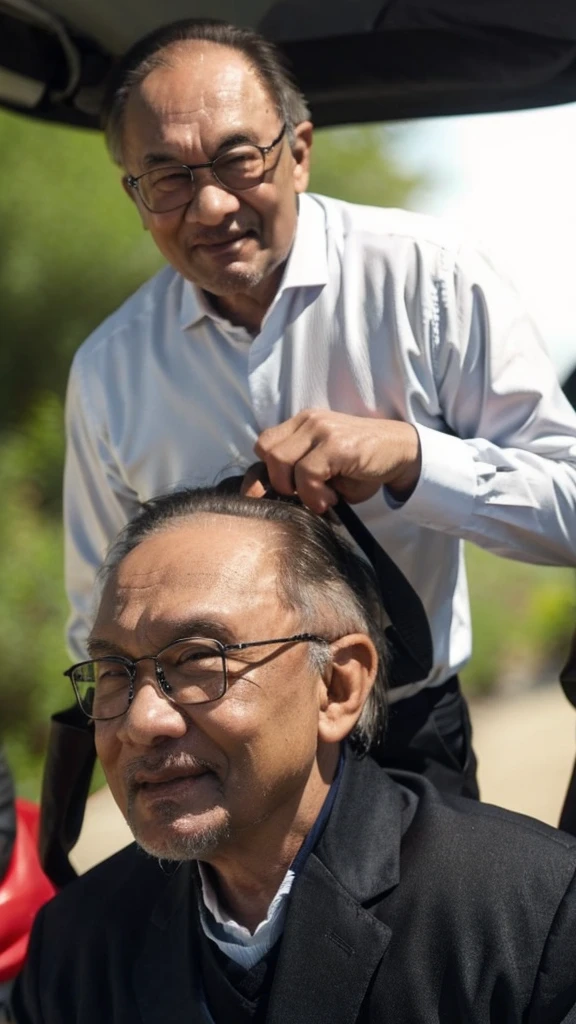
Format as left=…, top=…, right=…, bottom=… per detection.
left=90, top=515, right=338, bottom=859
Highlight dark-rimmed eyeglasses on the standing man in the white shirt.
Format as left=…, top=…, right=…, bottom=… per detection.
left=126, top=125, right=286, bottom=213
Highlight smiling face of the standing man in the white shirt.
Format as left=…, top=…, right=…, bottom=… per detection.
left=118, top=41, right=312, bottom=303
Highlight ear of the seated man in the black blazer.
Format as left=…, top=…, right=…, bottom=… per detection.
left=318, top=633, right=378, bottom=743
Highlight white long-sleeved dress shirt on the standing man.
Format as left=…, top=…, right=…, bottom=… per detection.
left=65, top=195, right=576, bottom=698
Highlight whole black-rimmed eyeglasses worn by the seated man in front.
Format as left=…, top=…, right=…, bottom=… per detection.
left=65, top=633, right=329, bottom=722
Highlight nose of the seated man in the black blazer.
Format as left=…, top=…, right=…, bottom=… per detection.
left=117, top=658, right=190, bottom=746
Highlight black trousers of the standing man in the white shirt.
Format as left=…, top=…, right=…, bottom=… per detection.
left=375, top=676, right=480, bottom=800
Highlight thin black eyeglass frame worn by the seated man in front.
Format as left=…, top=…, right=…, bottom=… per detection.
left=64, top=633, right=331, bottom=722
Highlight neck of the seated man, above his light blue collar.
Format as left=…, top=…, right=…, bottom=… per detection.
left=201, top=751, right=338, bottom=933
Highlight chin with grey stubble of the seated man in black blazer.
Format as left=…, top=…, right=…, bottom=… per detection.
left=128, top=808, right=230, bottom=861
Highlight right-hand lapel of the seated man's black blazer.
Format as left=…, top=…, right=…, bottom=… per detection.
left=266, top=754, right=414, bottom=1024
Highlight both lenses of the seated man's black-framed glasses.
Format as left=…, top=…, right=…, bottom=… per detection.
left=72, top=640, right=225, bottom=720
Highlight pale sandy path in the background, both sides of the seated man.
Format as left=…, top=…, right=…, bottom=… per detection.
left=73, top=685, right=576, bottom=870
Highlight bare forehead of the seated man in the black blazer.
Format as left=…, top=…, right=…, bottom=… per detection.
left=93, top=515, right=289, bottom=641
